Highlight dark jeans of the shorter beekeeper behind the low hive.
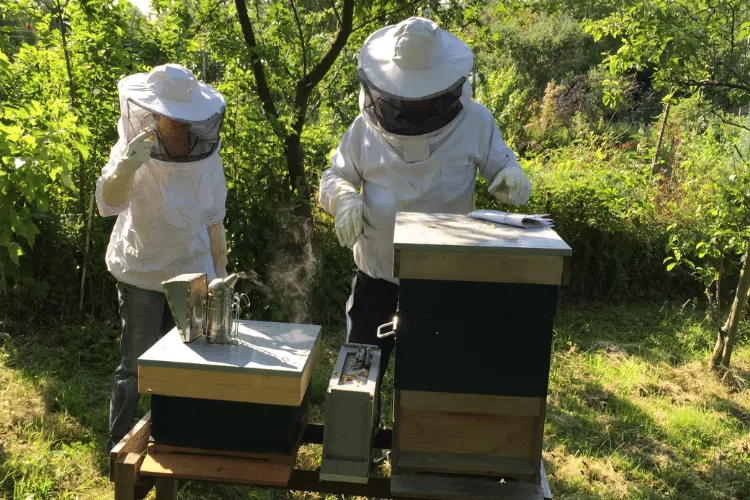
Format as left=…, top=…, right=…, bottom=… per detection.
left=106, top=282, right=174, bottom=452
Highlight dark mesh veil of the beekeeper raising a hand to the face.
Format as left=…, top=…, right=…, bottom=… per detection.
left=122, top=99, right=224, bottom=162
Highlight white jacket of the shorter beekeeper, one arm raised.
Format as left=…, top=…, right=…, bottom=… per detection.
left=96, top=126, right=227, bottom=292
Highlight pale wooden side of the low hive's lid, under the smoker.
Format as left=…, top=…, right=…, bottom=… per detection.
left=138, top=363, right=312, bottom=406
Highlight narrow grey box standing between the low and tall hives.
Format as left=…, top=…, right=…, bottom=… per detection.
left=320, top=343, right=380, bottom=483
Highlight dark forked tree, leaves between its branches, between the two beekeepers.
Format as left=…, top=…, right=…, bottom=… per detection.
left=235, top=0, right=440, bottom=220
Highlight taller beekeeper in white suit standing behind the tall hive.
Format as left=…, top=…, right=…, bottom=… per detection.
left=319, top=17, right=531, bottom=426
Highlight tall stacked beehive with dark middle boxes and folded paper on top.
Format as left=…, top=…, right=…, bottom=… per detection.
left=391, top=213, right=572, bottom=498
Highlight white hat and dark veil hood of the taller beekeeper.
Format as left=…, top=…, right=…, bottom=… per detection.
left=359, top=17, right=474, bottom=136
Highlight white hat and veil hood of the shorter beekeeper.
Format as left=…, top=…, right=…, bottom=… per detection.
left=117, top=64, right=226, bottom=162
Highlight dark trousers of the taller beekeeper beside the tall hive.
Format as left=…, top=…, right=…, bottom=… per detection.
left=346, top=271, right=398, bottom=424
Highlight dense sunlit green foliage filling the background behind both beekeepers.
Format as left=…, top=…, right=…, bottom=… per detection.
left=0, top=0, right=744, bottom=326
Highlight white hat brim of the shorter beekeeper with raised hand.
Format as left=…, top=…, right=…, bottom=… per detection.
left=117, top=73, right=226, bottom=122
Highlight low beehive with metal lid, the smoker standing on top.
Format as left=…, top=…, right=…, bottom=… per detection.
left=138, top=321, right=320, bottom=454
